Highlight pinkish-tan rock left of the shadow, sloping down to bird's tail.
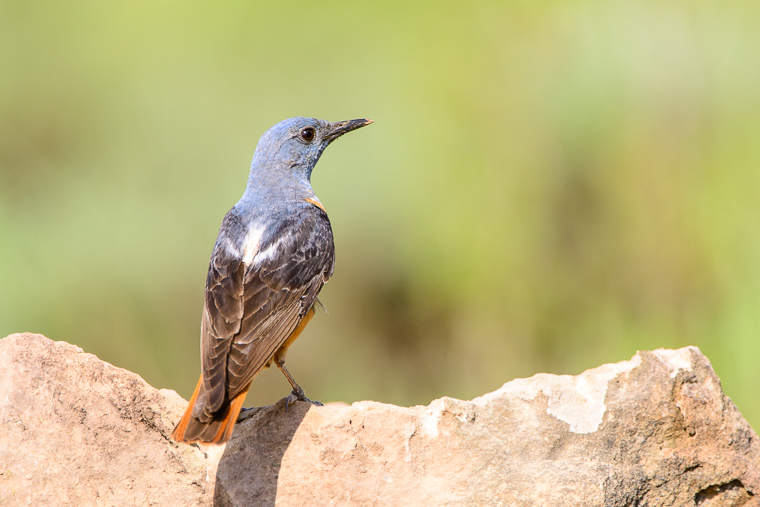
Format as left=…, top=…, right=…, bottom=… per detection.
left=0, top=333, right=223, bottom=506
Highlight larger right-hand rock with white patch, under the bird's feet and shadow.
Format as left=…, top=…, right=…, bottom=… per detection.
left=215, top=347, right=760, bottom=507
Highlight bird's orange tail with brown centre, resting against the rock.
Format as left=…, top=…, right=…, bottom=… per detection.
left=172, top=376, right=250, bottom=444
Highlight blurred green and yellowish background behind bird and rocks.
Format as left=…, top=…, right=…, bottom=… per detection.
left=0, top=0, right=760, bottom=428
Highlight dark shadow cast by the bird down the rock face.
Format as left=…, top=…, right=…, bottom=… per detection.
left=214, top=398, right=312, bottom=507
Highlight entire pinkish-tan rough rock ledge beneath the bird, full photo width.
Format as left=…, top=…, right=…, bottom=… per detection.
left=0, top=334, right=760, bottom=507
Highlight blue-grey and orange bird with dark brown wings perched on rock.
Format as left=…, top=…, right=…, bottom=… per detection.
left=171, top=117, right=373, bottom=444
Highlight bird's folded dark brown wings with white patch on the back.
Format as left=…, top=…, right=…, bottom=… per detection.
left=193, top=206, right=335, bottom=421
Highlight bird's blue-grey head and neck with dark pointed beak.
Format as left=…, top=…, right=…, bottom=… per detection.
left=246, top=116, right=372, bottom=193
